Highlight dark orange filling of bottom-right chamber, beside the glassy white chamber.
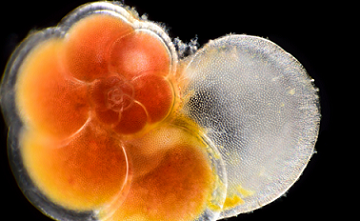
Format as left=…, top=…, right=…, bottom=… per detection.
left=107, top=142, right=214, bottom=221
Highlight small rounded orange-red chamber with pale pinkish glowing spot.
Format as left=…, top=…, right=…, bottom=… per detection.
left=111, top=31, right=171, bottom=79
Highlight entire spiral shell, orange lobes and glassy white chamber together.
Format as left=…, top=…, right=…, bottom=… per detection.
left=0, top=2, right=320, bottom=221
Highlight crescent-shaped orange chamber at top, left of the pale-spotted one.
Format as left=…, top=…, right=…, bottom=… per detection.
left=64, top=14, right=134, bottom=82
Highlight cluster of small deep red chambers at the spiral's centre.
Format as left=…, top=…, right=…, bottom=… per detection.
left=90, top=74, right=174, bottom=134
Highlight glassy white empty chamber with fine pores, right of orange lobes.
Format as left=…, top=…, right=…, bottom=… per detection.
left=183, top=35, right=320, bottom=217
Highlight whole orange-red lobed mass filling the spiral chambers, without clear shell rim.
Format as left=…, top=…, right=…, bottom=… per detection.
left=16, top=9, right=214, bottom=221
